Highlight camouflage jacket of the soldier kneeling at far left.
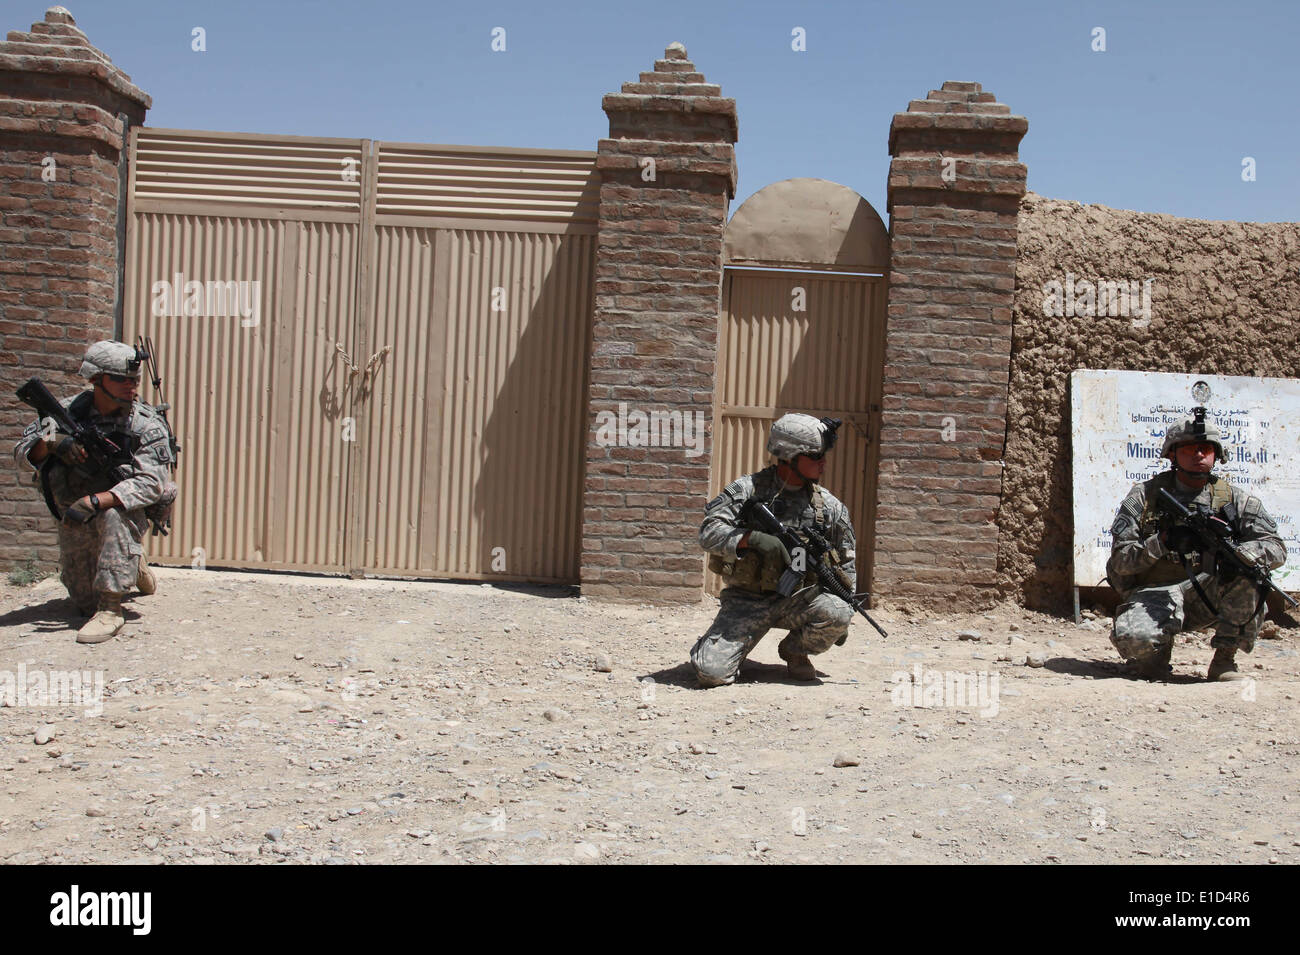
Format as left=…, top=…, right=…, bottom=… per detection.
left=13, top=391, right=174, bottom=511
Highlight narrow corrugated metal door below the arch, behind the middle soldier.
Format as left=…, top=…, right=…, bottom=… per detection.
left=706, top=269, right=885, bottom=594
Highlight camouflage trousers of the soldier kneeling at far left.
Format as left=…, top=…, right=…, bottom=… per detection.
left=59, top=507, right=148, bottom=612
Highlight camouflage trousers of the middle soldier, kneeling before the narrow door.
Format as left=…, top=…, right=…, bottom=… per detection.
left=690, top=587, right=853, bottom=686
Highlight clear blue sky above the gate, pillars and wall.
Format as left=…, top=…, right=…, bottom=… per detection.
left=12, top=0, right=1300, bottom=222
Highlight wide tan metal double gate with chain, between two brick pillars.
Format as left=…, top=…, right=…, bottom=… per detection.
left=124, top=129, right=598, bottom=582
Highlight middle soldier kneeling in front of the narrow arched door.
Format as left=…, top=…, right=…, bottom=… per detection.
left=690, top=414, right=857, bottom=686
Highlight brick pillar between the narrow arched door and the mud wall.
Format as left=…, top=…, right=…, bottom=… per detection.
left=874, top=83, right=1028, bottom=607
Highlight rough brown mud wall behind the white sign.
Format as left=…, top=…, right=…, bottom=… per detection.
left=998, top=194, right=1300, bottom=613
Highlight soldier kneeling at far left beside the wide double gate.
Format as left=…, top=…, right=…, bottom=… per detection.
left=14, top=342, right=176, bottom=643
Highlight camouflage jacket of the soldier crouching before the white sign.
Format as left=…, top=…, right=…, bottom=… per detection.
left=1106, top=470, right=1287, bottom=595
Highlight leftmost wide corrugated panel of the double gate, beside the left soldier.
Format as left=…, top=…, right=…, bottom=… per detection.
left=124, top=213, right=293, bottom=565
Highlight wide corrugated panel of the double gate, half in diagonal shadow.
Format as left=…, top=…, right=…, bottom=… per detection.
left=425, top=230, right=595, bottom=581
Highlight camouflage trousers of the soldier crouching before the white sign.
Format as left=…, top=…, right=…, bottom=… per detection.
left=1110, top=573, right=1266, bottom=663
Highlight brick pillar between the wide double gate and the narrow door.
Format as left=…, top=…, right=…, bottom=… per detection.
left=581, top=43, right=736, bottom=602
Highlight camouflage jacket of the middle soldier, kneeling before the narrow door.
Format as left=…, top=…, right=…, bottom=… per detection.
left=699, top=465, right=858, bottom=590
